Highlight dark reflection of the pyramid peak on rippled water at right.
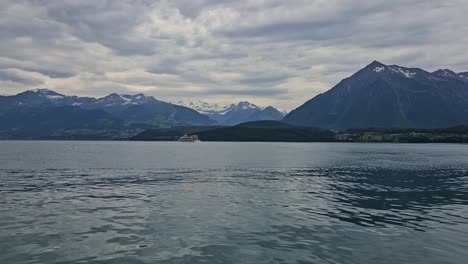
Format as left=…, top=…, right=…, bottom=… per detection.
left=301, top=168, right=468, bottom=230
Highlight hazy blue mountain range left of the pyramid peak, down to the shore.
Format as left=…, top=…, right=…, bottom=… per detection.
left=0, top=89, right=283, bottom=138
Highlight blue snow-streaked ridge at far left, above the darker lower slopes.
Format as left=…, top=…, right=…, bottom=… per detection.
left=0, top=89, right=214, bottom=125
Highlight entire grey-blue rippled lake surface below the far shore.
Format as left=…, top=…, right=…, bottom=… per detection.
left=0, top=141, right=468, bottom=264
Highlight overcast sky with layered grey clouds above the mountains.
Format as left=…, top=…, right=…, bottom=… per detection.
left=0, top=0, right=468, bottom=109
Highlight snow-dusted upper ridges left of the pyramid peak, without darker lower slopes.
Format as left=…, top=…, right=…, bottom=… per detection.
left=0, top=88, right=284, bottom=130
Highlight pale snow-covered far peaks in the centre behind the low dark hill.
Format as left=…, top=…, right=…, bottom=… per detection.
left=175, top=100, right=285, bottom=126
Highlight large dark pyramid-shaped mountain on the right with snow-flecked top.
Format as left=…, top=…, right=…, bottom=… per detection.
left=283, top=61, right=468, bottom=129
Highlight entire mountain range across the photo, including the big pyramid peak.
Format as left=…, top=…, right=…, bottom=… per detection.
left=0, top=61, right=468, bottom=139
